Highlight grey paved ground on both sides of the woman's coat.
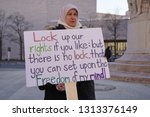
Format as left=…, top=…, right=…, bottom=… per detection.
left=0, top=68, right=150, bottom=100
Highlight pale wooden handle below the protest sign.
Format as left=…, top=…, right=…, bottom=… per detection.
left=65, top=82, right=78, bottom=100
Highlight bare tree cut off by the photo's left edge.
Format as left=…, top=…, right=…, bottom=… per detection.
left=0, top=10, right=7, bottom=60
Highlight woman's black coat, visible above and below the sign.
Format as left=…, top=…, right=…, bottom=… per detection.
left=39, top=25, right=95, bottom=100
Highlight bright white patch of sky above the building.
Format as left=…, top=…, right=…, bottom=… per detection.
left=97, top=0, right=128, bottom=15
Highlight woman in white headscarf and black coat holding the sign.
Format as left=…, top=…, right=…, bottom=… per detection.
left=39, top=4, right=95, bottom=100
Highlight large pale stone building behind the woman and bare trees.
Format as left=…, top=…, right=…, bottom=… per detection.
left=0, top=0, right=127, bottom=60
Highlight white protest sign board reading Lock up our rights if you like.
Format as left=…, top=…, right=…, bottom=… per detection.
left=24, top=28, right=110, bottom=87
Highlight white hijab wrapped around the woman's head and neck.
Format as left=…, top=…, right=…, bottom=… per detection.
left=58, top=4, right=82, bottom=29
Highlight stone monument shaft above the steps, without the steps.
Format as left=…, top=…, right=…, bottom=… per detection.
left=117, top=0, right=150, bottom=63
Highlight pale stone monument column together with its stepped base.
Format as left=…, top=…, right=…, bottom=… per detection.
left=110, top=0, right=150, bottom=83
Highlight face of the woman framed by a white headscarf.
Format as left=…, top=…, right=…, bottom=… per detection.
left=65, top=9, right=78, bottom=27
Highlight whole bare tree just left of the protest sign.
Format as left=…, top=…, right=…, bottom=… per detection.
left=8, top=13, right=32, bottom=61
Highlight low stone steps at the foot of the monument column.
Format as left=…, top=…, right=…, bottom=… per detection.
left=109, top=62, right=150, bottom=84
